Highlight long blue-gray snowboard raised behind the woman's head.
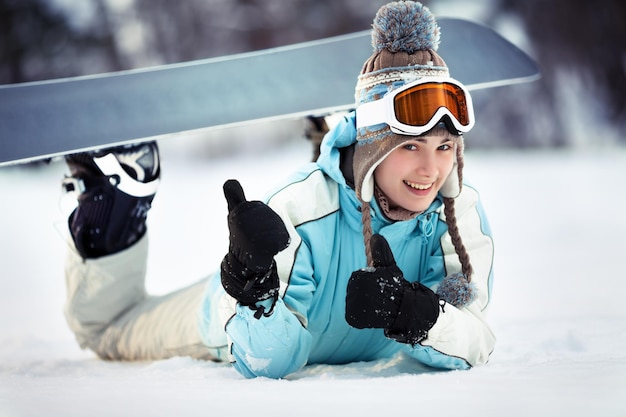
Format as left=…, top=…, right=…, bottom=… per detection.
left=0, top=18, right=539, bottom=166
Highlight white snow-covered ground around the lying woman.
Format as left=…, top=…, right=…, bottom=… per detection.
left=0, top=138, right=626, bottom=417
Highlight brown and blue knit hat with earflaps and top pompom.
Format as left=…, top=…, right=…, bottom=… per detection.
left=353, top=1, right=463, bottom=202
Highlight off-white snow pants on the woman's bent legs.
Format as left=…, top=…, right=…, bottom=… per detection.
left=65, top=237, right=213, bottom=360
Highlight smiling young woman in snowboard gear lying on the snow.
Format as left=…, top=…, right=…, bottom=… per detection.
left=66, top=1, right=495, bottom=378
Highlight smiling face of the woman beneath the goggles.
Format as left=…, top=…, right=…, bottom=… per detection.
left=374, top=134, right=455, bottom=212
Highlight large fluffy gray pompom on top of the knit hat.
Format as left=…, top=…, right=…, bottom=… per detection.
left=372, top=1, right=440, bottom=54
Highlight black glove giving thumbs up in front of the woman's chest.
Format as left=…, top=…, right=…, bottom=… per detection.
left=346, top=235, right=439, bottom=345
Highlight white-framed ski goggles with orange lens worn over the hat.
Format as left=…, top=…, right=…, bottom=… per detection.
left=356, top=77, right=474, bottom=135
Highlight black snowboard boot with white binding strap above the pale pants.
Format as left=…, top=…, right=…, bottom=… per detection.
left=63, top=142, right=161, bottom=258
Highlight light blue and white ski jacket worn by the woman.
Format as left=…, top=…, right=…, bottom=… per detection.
left=199, top=110, right=495, bottom=378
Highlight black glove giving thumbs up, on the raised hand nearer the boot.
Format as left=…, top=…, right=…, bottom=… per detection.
left=221, top=180, right=289, bottom=317
